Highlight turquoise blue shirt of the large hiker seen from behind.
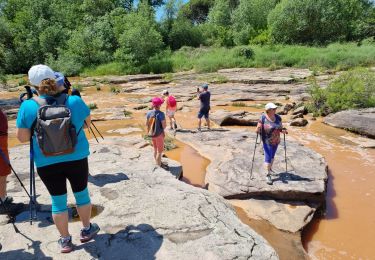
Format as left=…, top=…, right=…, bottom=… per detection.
left=16, top=96, right=90, bottom=167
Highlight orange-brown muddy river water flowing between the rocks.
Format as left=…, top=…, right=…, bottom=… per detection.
left=0, top=82, right=375, bottom=259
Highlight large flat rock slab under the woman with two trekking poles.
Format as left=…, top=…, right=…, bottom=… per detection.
left=176, top=130, right=328, bottom=203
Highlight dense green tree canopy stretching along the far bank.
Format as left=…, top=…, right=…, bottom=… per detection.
left=0, top=0, right=375, bottom=74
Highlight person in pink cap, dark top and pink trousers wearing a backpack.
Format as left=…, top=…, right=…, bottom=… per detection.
left=146, top=97, right=167, bottom=167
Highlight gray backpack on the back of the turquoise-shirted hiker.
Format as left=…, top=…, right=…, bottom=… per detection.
left=33, top=94, right=81, bottom=156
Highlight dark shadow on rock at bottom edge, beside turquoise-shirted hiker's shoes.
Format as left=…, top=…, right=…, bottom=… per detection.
left=79, top=224, right=163, bottom=260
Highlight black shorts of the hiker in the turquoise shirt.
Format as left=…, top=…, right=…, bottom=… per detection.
left=37, top=158, right=89, bottom=196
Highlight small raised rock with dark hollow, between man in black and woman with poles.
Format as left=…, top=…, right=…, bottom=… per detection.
left=210, top=110, right=261, bottom=126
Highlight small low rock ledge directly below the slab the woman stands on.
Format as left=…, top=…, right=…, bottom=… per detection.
left=230, top=199, right=316, bottom=233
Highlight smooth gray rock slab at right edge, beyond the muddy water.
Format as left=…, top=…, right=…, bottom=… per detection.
left=323, top=107, right=375, bottom=138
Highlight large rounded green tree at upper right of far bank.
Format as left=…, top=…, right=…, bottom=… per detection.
left=268, top=0, right=372, bottom=44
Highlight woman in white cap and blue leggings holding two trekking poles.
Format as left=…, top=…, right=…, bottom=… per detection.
left=256, top=103, right=288, bottom=185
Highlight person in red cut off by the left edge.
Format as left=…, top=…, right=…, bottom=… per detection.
left=0, top=109, right=13, bottom=204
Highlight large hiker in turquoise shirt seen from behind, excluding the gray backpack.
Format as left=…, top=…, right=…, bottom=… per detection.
left=16, top=65, right=100, bottom=253
